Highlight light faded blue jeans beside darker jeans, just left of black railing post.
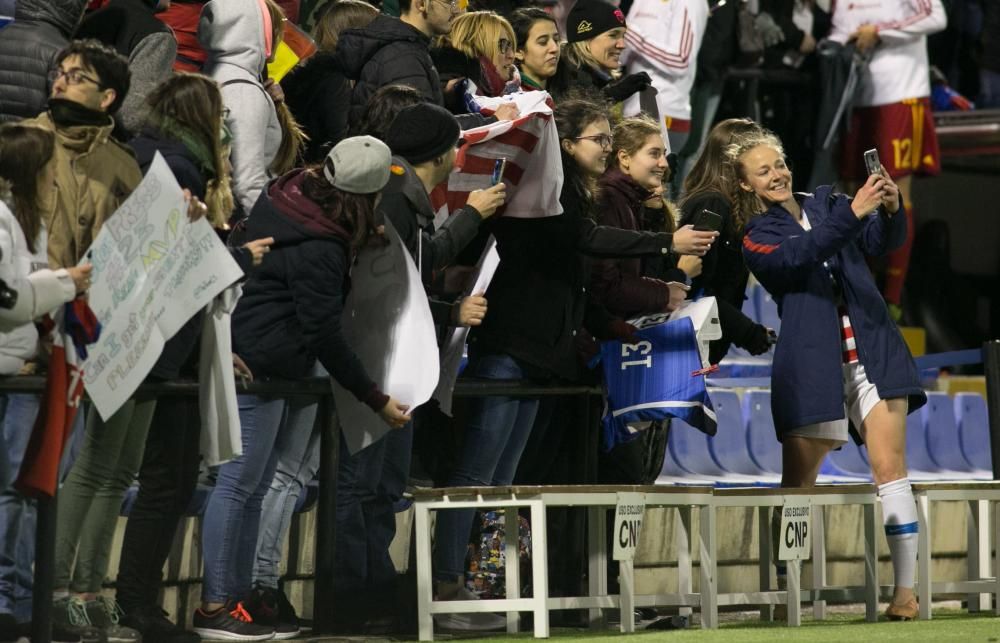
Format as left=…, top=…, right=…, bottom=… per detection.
left=253, top=400, right=320, bottom=588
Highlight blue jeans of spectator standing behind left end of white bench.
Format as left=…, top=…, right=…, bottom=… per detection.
left=434, top=355, right=538, bottom=582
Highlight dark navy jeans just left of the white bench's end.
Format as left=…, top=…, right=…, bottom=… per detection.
left=333, top=422, right=413, bottom=604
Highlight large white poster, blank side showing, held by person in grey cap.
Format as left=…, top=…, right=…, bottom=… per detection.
left=331, top=219, right=440, bottom=453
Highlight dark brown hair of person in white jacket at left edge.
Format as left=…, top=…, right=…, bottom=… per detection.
left=0, top=123, right=56, bottom=253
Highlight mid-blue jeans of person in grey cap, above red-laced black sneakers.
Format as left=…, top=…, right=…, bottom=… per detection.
left=201, top=395, right=316, bottom=603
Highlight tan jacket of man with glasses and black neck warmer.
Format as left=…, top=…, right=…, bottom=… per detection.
left=20, top=112, right=142, bottom=268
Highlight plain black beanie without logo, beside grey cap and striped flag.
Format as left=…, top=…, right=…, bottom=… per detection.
left=385, top=103, right=462, bottom=165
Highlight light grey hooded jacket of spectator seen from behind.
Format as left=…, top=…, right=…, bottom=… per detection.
left=198, top=0, right=281, bottom=212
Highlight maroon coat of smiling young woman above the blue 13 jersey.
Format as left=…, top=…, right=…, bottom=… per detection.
left=591, top=168, right=670, bottom=319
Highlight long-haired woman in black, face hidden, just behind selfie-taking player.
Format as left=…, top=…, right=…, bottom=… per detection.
left=681, top=118, right=771, bottom=364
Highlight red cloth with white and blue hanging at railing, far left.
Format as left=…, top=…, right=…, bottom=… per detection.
left=15, top=299, right=101, bottom=498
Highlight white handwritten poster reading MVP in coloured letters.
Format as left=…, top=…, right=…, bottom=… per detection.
left=83, top=153, right=243, bottom=419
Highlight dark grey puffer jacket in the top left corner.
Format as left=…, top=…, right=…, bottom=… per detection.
left=0, top=0, right=86, bottom=122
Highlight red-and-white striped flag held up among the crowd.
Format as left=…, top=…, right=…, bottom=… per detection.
left=431, top=92, right=563, bottom=225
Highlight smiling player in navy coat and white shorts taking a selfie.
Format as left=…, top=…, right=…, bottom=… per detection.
left=740, top=124, right=927, bottom=620
